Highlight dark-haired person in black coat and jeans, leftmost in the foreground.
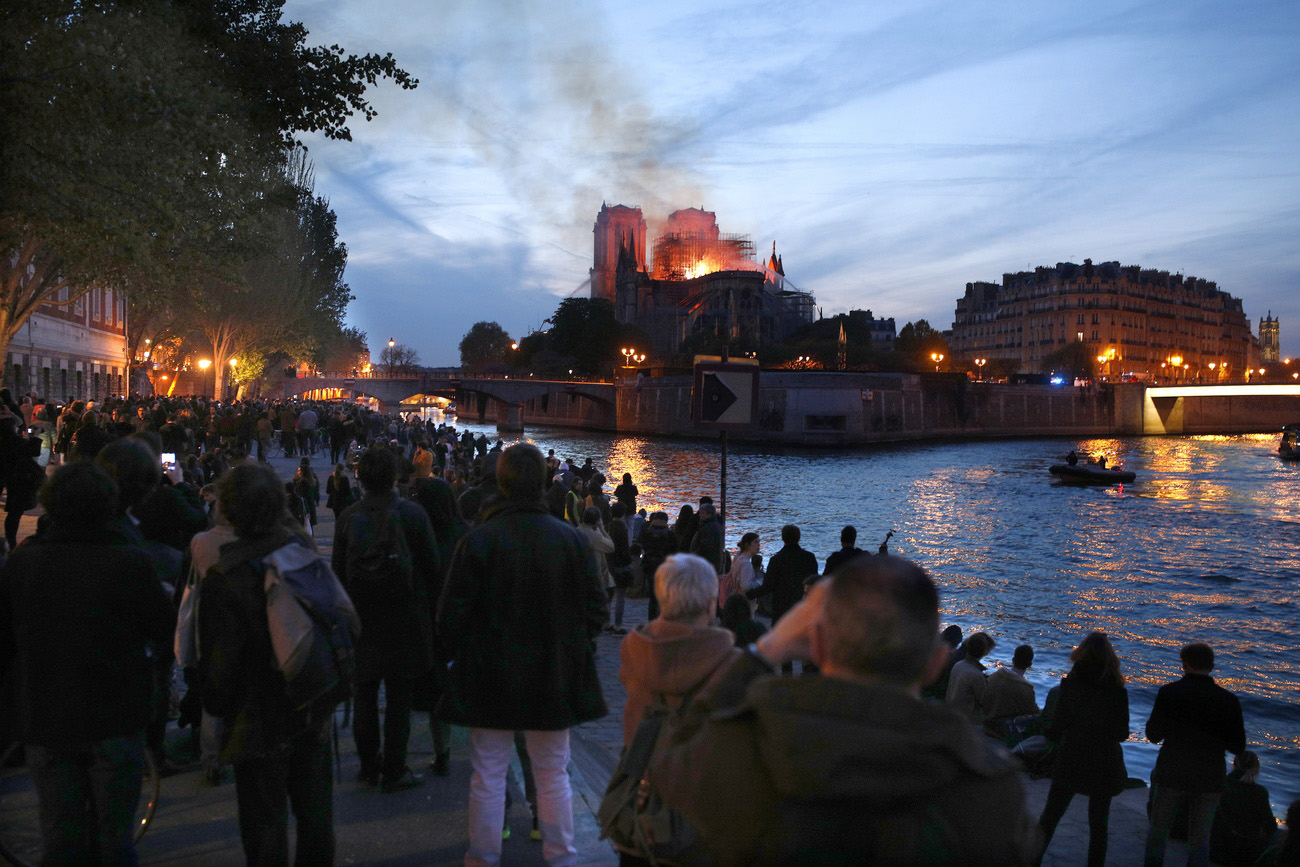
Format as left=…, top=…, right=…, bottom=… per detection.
left=0, top=463, right=172, bottom=864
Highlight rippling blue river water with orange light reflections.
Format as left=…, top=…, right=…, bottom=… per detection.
left=441, top=420, right=1300, bottom=816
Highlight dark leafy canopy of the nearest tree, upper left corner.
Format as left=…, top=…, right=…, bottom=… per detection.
left=0, top=0, right=417, bottom=369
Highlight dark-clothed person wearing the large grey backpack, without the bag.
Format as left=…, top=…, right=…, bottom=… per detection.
left=199, top=463, right=339, bottom=864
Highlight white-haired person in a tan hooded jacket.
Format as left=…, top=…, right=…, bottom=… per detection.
left=619, top=554, right=740, bottom=746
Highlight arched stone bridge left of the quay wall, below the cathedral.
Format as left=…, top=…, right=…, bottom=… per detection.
left=283, top=373, right=615, bottom=430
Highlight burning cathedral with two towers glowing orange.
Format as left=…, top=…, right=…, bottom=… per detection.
left=592, top=204, right=815, bottom=356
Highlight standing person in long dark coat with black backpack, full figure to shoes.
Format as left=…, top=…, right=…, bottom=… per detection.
left=333, top=445, right=441, bottom=793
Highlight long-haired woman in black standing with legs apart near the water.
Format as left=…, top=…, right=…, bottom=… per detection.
left=1035, top=632, right=1128, bottom=867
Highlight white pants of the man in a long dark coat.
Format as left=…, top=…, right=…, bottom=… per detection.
left=465, top=728, right=577, bottom=867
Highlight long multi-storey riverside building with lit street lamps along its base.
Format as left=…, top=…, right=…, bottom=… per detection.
left=948, top=259, right=1258, bottom=382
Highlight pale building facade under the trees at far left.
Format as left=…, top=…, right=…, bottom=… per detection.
left=4, top=289, right=129, bottom=402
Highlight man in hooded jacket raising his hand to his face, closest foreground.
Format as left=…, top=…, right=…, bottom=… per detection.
left=649, top=556, right=1036, bottom=864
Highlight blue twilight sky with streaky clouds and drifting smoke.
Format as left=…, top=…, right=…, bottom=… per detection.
left=285, top=0, right=1300, bottom=365
